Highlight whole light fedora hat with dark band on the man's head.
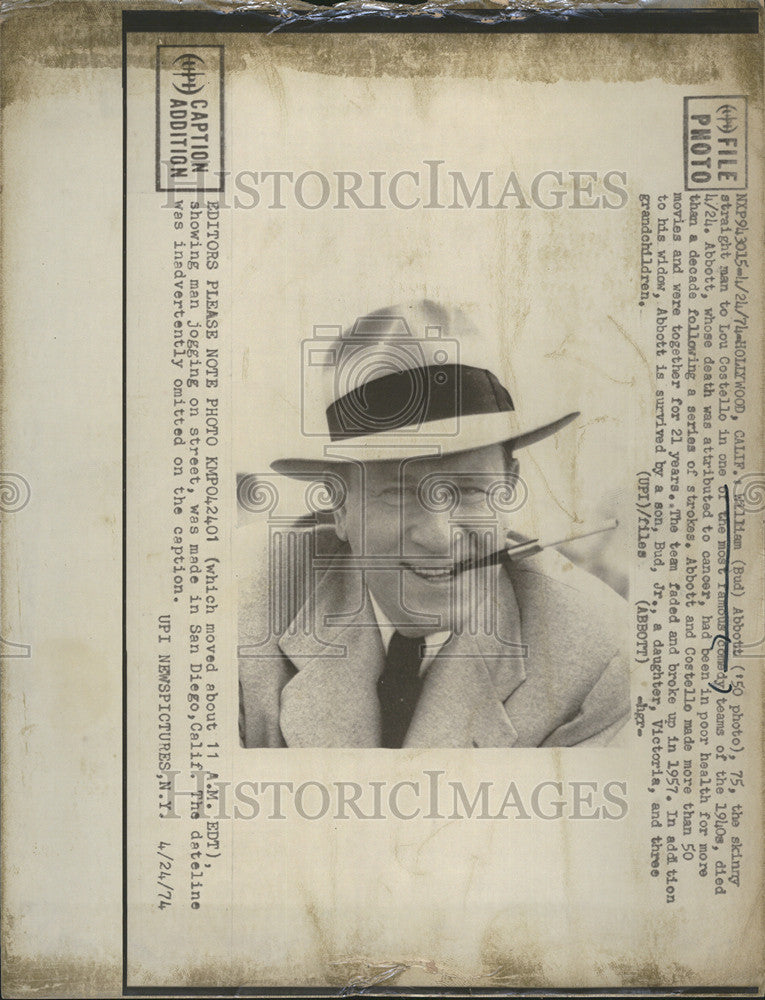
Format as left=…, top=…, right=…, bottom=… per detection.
left=271, top=299, right=579, bottom=479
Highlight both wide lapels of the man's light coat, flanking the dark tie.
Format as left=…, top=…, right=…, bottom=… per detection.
left=279, top=570, right=527, bottom=747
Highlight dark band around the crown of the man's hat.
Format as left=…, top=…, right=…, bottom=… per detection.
left=327, top=365, right=515, bottom=441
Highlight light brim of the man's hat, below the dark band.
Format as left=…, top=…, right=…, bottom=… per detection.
left=271, top=410, right=579, bottom=479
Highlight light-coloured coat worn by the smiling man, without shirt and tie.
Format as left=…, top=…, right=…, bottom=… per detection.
left=239, top=526, right=630, bottom=747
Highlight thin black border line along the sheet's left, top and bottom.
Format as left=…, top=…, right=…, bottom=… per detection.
left=122, top=6, right=760, bottom=998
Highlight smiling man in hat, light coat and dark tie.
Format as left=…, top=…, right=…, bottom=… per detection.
left=240, top=301, right=630, bottom=749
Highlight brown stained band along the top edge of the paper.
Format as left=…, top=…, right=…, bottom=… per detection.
left=0, top=0, right=762, bottom=105
